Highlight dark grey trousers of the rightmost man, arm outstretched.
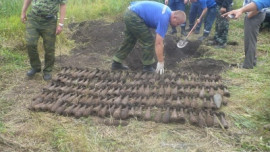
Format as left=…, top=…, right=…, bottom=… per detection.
left=243, top=13, right=265, bottom=69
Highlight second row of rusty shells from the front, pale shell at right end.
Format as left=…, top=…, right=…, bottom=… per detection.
left=34, top=91, right=228, bottom=110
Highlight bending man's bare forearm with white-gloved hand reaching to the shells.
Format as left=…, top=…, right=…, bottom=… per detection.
left=155, top=33, right=164, bottom=74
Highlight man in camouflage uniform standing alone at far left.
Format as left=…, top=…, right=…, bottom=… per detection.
left=21, top=0, right=67, bottom=80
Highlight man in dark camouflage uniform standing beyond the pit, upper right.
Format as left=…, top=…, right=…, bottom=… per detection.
left=213, top=0, right=232, bottom=48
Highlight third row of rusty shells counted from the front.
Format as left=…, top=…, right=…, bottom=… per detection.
left=44, top=81, right=230, bottom=99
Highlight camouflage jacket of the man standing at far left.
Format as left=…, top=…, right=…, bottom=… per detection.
left=32, top=0, right=67, bottom=16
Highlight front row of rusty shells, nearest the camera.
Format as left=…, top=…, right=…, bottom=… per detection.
left=30, top=100, right=228, bottom=129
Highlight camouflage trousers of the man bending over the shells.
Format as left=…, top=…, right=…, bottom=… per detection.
left=113, top=9, right=155, bottom=65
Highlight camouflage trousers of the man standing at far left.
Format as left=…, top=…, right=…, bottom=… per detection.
left=25, top=14, right=57, bottom=72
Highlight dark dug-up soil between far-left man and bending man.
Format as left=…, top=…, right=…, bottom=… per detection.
left=60, top=20, right=125, bottom=68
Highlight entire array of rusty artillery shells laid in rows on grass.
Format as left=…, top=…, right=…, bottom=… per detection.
left=29, top=67, right=230, bottom=128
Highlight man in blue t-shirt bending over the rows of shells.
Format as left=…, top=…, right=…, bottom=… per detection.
left=111, top=1, right=186, bottom=74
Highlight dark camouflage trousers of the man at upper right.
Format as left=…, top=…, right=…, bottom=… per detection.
left=214, top=5, right=229, bottom=45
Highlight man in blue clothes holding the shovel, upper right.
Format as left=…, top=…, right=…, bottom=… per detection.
left=190, top=0, right=217, bottom=41
